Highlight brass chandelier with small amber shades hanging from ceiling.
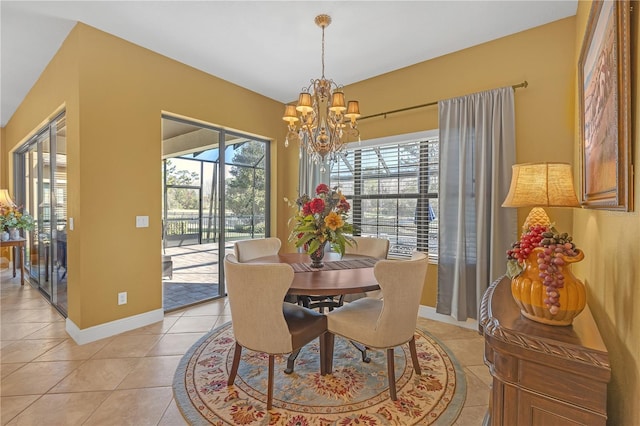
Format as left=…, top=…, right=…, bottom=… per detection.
left=282, top=15, right=360, bottom=172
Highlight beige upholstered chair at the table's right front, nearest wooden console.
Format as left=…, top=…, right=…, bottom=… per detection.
left=325, top=252, right=429, bottom=401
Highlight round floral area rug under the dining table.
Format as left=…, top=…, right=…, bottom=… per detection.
left=173, top=323, right=466, bottom=426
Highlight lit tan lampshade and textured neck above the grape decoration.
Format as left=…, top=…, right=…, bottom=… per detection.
left=502, top=163, right=580, bottom=230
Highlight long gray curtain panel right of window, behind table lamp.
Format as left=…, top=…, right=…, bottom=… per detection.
left=436, top=87, right=517, bottom=321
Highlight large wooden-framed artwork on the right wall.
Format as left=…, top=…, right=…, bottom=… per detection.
left=578, top=0, right=633, bottom=211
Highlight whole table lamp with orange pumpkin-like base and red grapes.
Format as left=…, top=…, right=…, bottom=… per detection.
left=502, top=163, right=586, bottom=325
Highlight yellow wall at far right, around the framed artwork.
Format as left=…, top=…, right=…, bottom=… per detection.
left=573, top=2, right=640, bottom=425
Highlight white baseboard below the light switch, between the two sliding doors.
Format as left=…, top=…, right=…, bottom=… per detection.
left=66, top=309, right=164, bottom=345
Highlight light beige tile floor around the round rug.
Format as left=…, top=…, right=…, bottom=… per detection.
left=0, top=269, right=490, bottom=426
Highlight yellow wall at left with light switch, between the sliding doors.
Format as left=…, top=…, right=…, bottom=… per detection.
left=3, top=24, right=284, bottom=329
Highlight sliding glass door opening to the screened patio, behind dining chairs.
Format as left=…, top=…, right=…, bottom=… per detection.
left=162, top=116, right=269, bottom=311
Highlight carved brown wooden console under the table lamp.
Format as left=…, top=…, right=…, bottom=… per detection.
left=479, top=277, right=611, bottom=426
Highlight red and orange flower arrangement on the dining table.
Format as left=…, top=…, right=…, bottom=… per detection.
left=285, top=183, right=355, bottom=255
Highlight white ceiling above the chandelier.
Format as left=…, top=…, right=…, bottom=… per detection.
left=0, top=0, right=578, bottom=126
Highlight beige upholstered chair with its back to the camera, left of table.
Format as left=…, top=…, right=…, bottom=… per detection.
left=224, top=254, right=327, bottom=410
